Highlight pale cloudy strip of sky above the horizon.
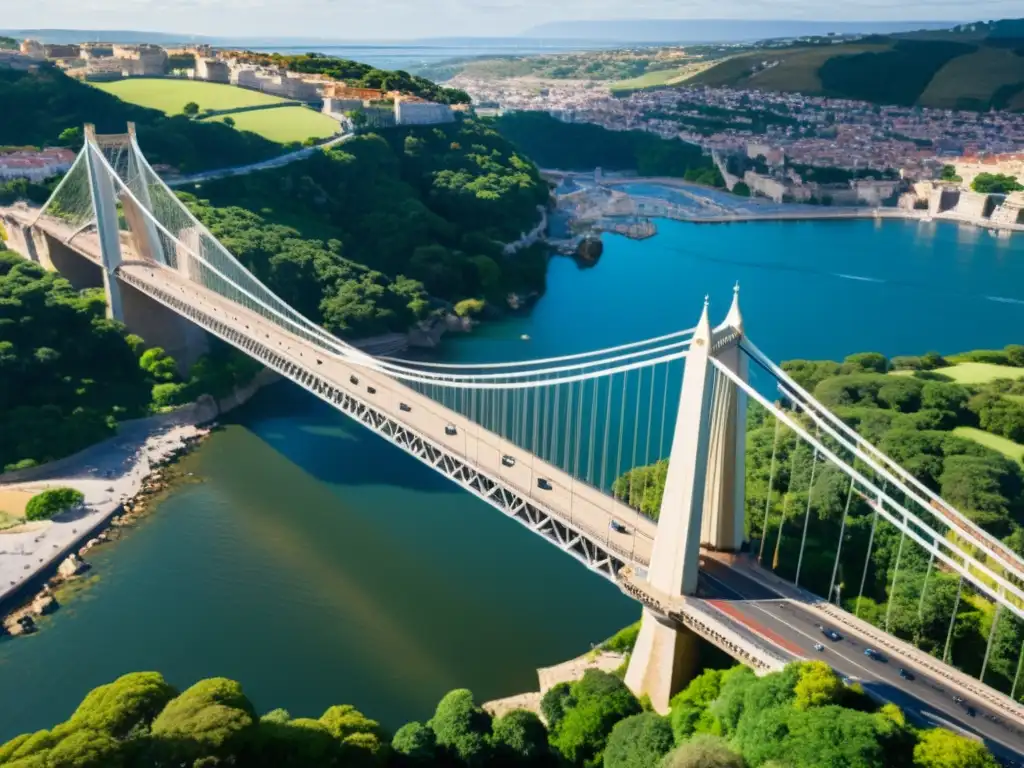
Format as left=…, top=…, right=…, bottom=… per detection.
left=0, top=0, right=1024, bottom=40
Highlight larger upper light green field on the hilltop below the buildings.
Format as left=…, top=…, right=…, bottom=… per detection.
left=92, top=78, right=286, bottom=115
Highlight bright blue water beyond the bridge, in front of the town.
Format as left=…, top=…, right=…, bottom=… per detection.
left=445, top=220, right=1024, bottom=370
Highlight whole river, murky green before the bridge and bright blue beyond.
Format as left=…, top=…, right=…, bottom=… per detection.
left=0, top=221, right=1024, bottom=740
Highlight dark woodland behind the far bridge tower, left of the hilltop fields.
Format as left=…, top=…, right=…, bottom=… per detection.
left=0, top=66, right=284, bottom=172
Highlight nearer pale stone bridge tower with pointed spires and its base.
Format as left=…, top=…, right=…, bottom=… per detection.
left=626, top=285, right=748, bottom=712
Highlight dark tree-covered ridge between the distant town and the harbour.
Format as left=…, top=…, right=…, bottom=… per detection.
left=495, top=112, right=724, bottom=186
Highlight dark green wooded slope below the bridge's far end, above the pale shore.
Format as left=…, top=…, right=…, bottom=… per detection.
left=0, top=249, right=259, bottom=471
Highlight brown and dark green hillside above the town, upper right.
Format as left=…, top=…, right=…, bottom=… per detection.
left=686, top=34, right=1024, bottom=111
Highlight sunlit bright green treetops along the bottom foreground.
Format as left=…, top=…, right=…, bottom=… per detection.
left=0, top=662, right=997, bottom=768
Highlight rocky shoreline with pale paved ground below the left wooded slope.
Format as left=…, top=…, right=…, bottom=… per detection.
left=0, top=370, right=280, bottom=636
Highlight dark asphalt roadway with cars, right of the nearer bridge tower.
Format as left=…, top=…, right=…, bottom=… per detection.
left=701, top=558, right=1024, bottom=765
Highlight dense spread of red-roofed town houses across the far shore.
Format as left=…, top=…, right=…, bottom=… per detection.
left=447, top=75, right=1024, bottom=188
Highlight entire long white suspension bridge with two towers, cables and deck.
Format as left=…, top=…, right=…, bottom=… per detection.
left=6, top=126, right=1024, bottom=757
